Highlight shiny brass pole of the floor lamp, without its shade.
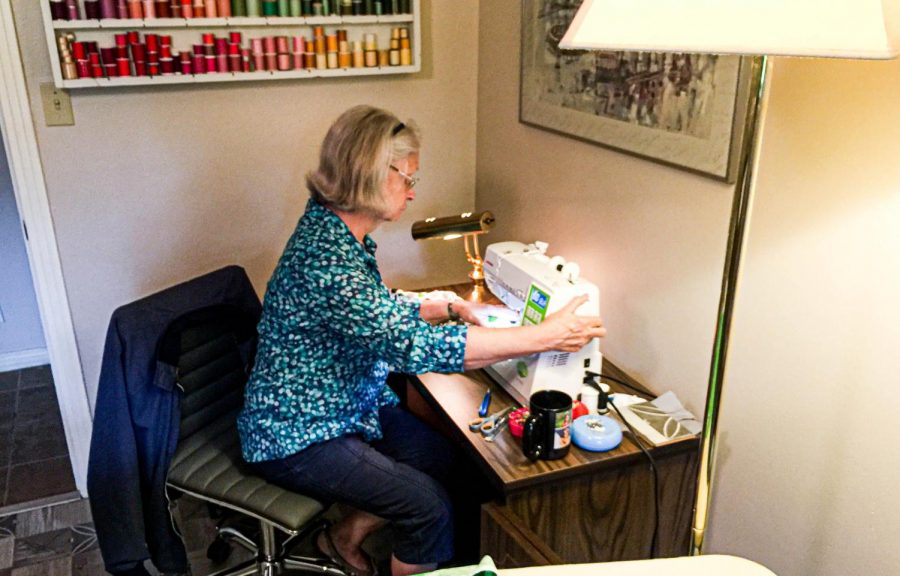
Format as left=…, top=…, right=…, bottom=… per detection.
left=690, top=56, right=771, bottom=556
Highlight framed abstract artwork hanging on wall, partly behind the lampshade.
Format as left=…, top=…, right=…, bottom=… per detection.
left=519, top=0, right=749, bottom=182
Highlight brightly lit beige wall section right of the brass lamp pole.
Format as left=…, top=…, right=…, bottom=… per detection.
left=710, top=59, right=900, bottom=576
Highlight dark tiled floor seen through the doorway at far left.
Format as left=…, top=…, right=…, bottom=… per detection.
left=0, top=366, right=75, bottom=513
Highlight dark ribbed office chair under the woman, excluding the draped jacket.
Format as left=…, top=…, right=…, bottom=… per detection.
left=157, top=304, right=346, bottom=576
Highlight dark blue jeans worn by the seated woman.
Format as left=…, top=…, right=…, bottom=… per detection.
left=254, top=406, right=453, bottom=564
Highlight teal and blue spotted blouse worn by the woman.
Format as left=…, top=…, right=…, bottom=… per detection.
left=238, top=200, right=467, bottom=462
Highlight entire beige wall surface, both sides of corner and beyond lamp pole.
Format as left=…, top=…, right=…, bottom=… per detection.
left=14, top=0, right=900, bottom=576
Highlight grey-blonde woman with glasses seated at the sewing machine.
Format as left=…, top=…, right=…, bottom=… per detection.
left=238, top=106, right=605, bottom=576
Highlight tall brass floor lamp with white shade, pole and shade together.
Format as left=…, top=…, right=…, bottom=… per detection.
left=560, top=0, right=900, bottom=555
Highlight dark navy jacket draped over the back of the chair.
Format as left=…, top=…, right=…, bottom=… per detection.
left=88, top=266, right=261, bottom=574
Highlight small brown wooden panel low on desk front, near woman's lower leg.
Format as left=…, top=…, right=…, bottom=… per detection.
left=481, top=503, right=563, bottom=568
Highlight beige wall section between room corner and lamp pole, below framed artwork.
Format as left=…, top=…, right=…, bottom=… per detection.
left=477, top=0, right=731, bottom=410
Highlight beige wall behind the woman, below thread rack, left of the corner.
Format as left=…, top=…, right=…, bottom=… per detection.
left=13, top=0, right=478, bottom=403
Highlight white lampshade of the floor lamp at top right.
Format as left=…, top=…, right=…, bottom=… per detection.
left=559, top=0, right=900, bottom=59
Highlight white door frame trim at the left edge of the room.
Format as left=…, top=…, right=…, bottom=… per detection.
left=0, top=1, right=92, bottom=497
